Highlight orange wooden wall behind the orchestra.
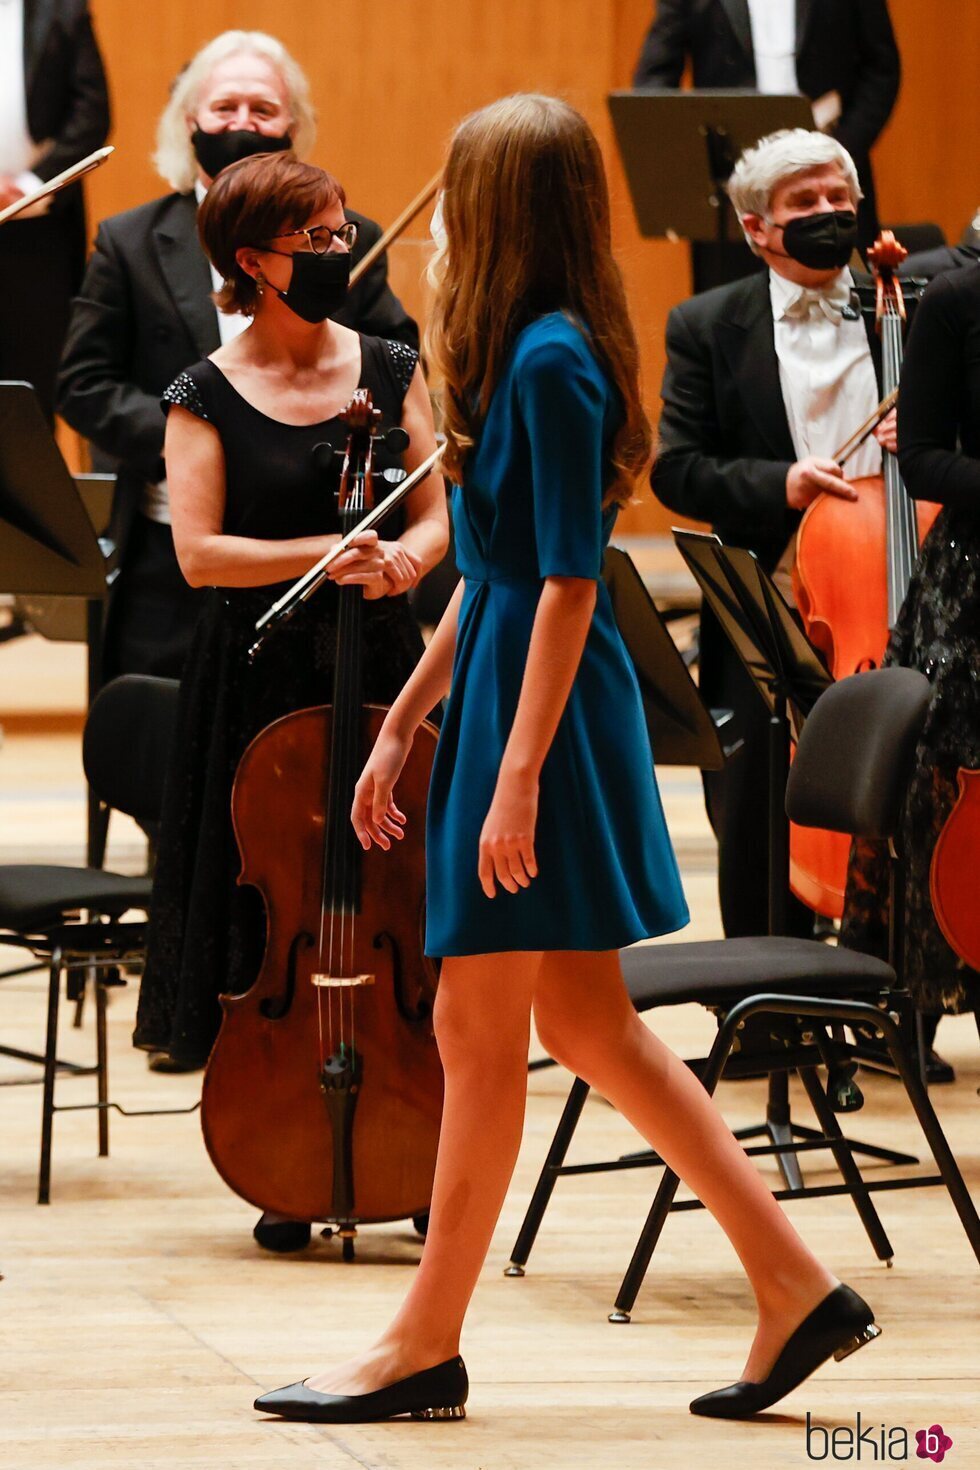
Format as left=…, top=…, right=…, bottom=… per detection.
left=90, top=0, right=980, bottom=532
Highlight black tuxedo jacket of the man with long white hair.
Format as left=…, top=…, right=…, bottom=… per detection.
left=57, top=194, right=419, bottom=541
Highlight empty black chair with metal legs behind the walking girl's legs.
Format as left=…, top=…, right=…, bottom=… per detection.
left=505, top=669, right=980, bottom=1322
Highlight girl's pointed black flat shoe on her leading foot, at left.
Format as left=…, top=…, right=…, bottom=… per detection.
left=256, top=1357, right=470, bottom=1424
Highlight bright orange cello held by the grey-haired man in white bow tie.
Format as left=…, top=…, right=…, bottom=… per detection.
left=789, top=229, right=940, bottom=919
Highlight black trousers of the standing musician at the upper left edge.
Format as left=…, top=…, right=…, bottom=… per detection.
left=0, top=213, right=79, bottom=419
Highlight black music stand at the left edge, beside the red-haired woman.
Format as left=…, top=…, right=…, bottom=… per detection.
left=0, top=382, right=107, bottom=866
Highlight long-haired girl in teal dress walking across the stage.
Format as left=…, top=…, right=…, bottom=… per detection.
left=256, top=96, right=873, bottom=1423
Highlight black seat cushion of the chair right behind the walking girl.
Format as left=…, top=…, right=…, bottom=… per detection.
left=620, top=935, right=896, bottom=1010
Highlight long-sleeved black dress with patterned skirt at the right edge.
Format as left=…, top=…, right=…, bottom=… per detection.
left=840, top=265, right=980, bottom=1014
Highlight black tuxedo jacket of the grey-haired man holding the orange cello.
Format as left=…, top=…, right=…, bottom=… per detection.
left=651, top=270, right=882, bottom=570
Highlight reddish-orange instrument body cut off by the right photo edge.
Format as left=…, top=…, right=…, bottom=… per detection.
left=929, top=767, right=980, bottom=970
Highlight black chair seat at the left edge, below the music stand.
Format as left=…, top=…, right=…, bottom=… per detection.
left=0, top=863, right=153, bottom=932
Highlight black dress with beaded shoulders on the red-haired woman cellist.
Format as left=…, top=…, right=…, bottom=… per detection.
left=134, top=337, right=423, bottom=1066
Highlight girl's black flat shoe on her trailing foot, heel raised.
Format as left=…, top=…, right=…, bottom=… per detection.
left=689, top=1286, right=882, bottom=1419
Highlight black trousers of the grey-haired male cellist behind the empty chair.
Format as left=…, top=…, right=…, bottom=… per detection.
left=701, top=610, right=814, bottom=939
